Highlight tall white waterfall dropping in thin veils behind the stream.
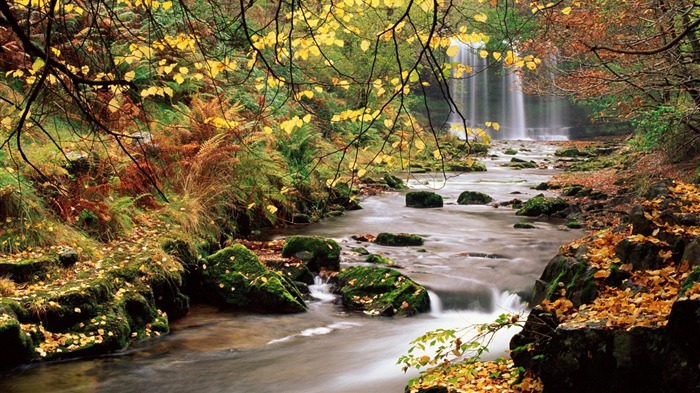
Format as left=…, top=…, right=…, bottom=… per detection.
left=448, top=41, right=572, bottom=140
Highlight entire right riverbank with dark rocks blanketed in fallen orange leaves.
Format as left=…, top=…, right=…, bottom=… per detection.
left=407, top=139, right=700, bottom=393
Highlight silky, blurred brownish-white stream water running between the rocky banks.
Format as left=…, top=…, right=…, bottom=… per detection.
left=0, top=142, right=582, bottom=393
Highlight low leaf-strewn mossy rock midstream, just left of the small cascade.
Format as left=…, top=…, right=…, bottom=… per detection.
left=336, top=266, right=430, bottom=316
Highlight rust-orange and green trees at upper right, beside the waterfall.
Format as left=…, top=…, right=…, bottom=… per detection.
left=521, top=0, right=700, bottom=159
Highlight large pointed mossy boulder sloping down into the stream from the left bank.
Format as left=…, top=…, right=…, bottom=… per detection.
left=202, top=244, right=306, bottom=313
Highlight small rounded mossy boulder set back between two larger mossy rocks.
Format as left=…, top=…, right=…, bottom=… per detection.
left=282, top=236, right=340, bottom=272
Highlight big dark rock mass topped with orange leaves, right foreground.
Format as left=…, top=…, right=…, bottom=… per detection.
left=510, top=184, right=700, bottom=393
